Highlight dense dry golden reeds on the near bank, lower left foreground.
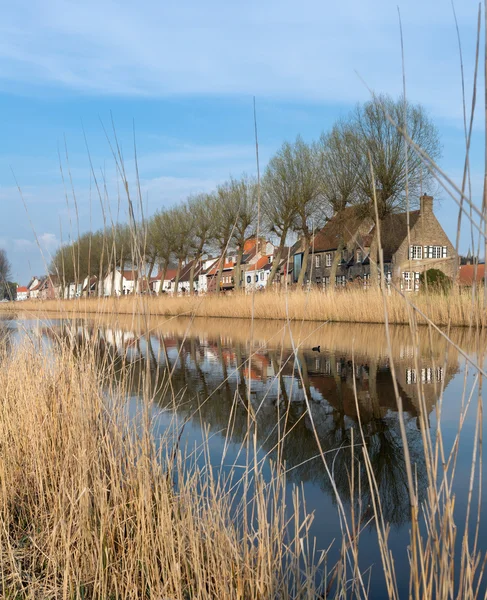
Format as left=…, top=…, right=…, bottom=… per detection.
left=0, top=340, right=328, bottom=600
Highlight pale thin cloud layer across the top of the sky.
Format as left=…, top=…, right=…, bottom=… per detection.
left=0, top=0, right=477, bottom=118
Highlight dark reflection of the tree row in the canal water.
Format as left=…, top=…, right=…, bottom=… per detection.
left=50, top=326, right=446, bottom=525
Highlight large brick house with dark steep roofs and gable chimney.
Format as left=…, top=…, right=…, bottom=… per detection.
left=293, top=195, right=458, bottom=291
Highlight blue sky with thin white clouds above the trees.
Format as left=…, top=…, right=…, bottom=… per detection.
left=0, top=0, right=484, bottom=285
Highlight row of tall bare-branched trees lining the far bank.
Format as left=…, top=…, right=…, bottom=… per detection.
left=52, top=96, right=441, bottom=291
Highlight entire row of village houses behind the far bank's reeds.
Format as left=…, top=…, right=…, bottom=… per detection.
left=17, top=195, right=484, bottom=300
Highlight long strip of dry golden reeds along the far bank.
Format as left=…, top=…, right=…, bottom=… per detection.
left=0, top=289, right=487, bottom=327
